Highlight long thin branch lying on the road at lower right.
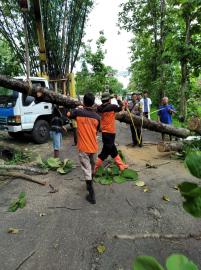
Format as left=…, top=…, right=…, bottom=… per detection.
left=114, top=233, right=201, bottom=241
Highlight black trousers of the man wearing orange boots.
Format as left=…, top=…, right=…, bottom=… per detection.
left=98, top=132, right=118, bottom=160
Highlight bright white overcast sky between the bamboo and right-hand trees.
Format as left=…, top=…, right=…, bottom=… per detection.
left=84, top=0, right=131, bottom=71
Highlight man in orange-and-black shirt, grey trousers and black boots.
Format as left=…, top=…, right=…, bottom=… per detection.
left=67, top=93, right=100, bottom=204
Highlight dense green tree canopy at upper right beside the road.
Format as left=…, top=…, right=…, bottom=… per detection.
left=119, top=0, right=201, bottom=116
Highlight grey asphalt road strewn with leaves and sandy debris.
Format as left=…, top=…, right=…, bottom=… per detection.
left=0, top=124, right=201, bottom=270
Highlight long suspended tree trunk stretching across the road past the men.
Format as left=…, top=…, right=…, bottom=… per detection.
left=0, top=75, right=190, bottom=138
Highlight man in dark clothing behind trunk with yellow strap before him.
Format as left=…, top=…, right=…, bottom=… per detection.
left=128, top=93, right=142, bottom=147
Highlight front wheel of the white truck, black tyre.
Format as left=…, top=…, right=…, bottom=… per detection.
left=31, top=120, right=50, bottom=144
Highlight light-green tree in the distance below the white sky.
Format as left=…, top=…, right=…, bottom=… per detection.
left=76, top=31, right=123, bottom=94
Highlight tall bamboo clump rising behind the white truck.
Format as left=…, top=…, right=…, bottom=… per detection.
left=0, top=0, right=93, bottom=78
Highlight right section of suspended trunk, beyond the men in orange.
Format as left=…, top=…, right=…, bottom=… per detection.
left=116, top=112, right=190, bottom=138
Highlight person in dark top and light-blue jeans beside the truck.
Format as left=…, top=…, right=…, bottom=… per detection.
left=50, top=105, right=67, bottom=158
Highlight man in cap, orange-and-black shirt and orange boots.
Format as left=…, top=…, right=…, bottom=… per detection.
left=95, top=92, right=128, bottom=172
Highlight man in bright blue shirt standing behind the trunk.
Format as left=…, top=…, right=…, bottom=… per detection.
left=158, top=97, right=176, bottom=141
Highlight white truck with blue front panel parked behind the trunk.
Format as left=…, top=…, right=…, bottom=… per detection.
left=0, top=76, right=52, bottom=144
